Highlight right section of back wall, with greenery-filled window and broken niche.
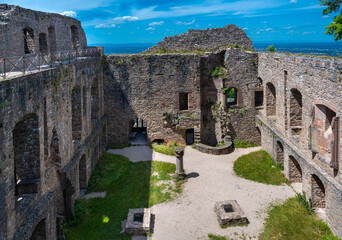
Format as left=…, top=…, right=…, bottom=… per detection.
left=202, top=48, right=262, bottom=145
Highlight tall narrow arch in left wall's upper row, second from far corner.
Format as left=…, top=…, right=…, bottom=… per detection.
left=71, top=86, right=82, bottom=141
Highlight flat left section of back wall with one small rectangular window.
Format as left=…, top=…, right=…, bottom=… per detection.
left=104, top=54, right=200, bottom=145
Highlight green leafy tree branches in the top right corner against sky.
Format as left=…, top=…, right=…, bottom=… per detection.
left=319, top=0, right=342, bottom=41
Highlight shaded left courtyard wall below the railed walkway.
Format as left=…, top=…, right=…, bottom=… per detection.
left=0, top=57, right=106, bottom=239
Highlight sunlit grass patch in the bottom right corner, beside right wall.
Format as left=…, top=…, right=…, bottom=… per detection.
left=259, top=198, right=339, bottom=240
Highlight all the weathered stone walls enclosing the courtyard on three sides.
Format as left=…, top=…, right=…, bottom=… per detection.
left=0, top=4, right=342, bottom=240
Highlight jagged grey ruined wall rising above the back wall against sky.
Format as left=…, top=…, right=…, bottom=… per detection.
left=146, top=24, right=253, bottom=53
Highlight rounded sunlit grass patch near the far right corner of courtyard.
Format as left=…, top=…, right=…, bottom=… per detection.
left=234, top=150, right=288, bottom=185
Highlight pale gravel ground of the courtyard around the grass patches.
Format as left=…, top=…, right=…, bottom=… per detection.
left=109, top=147, right=295, bottom=240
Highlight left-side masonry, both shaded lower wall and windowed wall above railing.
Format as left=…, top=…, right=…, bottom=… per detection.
left=0, top=5, right=107, bottom=240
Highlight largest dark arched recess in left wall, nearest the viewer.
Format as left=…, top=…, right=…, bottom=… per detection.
left=13, top=113, right=40, bottom=196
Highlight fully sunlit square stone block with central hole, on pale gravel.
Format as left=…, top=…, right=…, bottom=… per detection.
left=214, top=200, right=249, bottom=226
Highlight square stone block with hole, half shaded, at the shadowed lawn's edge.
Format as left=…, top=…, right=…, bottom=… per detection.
left=125, top=208, right=151, bottom=235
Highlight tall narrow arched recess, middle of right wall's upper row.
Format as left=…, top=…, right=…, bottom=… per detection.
left=290, top=88, right=303, bottom=135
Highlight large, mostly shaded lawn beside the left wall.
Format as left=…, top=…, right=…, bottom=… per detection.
left=64, top=153, right=182, bottom=240
